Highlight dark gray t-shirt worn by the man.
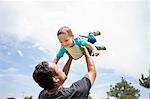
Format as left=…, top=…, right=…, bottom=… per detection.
left=38, top=77, right=91, bottom=99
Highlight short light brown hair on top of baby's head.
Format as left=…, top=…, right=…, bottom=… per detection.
left=57, top=26, right=73, bottom=36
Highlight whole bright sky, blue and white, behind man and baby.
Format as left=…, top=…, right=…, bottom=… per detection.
left=0, top=0, right=150, bottom=99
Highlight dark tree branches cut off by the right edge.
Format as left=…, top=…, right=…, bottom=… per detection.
left=139, top=70, right=150, bottom=88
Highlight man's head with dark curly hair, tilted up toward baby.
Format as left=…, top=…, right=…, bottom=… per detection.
left=33, top=61, right=67, bottom=90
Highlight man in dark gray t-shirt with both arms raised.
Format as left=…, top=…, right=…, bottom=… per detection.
left=33, top=48, right=96, bottom=99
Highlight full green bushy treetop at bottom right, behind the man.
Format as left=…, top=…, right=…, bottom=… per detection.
left=107, top=77, right=140, bottom=99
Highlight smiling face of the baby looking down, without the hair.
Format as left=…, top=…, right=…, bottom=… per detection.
left=58, top=33, right=73, bottom=48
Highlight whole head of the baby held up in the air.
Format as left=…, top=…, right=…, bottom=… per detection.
left=57, top=26, right=74, bottom=48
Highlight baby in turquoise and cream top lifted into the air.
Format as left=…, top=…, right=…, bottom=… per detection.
left=53, top=26, right=106, bottom=64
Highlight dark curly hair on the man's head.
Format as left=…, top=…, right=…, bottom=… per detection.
left=33, top=61, right=55, bottom=90
